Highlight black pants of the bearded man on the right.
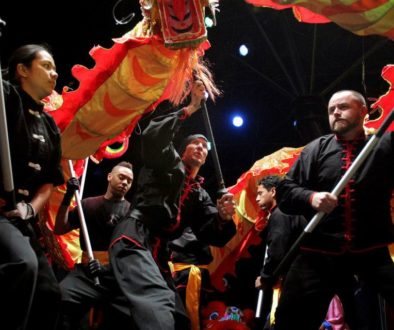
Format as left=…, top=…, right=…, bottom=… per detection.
left=275, top=248, right=394, bottom=330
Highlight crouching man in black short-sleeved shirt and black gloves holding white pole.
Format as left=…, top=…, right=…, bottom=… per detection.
left=54, top=161, right=134, bottom=330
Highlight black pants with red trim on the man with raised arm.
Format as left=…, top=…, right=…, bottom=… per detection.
left=109, top=218, right=190, bottom=330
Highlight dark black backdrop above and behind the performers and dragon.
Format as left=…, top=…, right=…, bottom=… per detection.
left=0, top=0, right=394, bottom=195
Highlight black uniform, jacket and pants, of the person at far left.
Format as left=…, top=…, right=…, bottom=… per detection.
left=0, top=83, right=64, bottom=329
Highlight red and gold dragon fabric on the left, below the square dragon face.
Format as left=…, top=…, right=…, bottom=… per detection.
left=40, top=0, right=217, bottom=269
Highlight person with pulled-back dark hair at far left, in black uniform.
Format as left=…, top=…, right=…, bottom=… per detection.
left=0, top=44, right=64, bottom=329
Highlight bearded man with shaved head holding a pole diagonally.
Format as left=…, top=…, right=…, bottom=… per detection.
left=275, top=90, right=394, bottom=330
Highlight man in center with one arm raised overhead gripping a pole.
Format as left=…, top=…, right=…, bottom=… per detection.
left=109, top=81, right=235, bottom=330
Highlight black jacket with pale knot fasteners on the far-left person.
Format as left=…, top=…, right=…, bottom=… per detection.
left=0, top=82, right=64, bottom=206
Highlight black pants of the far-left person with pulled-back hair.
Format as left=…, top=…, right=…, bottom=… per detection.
left=0, top=217, right=60, bottom=330
